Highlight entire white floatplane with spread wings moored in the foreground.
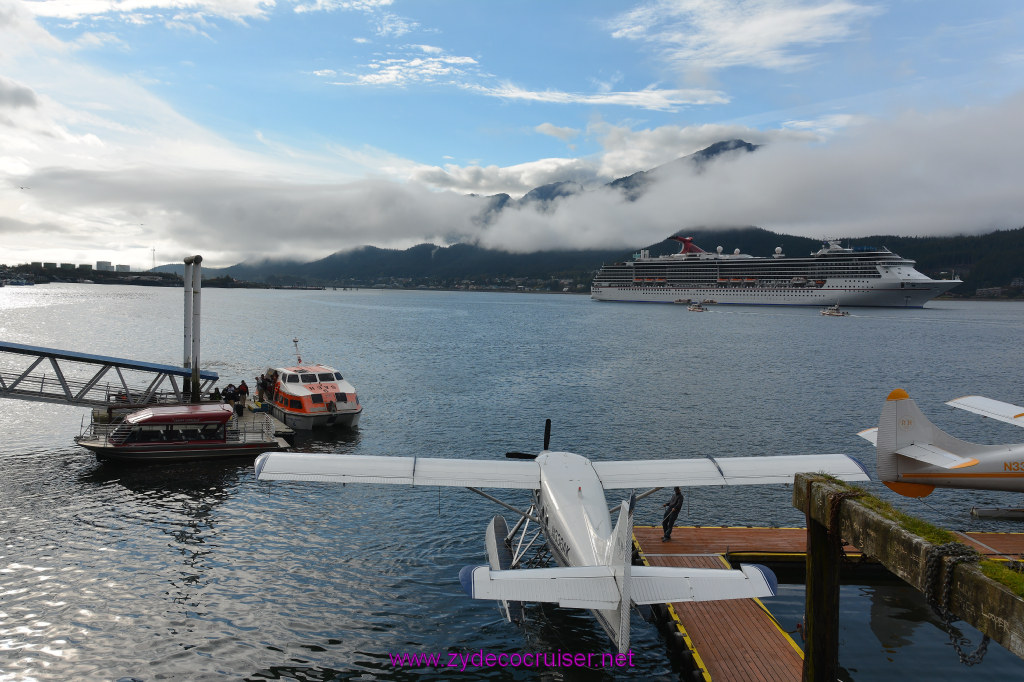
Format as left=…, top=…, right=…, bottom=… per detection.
left=255, top=426, right=869, bottom=653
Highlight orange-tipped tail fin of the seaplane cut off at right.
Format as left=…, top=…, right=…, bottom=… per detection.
left=876, top=388, right=980, bottom=489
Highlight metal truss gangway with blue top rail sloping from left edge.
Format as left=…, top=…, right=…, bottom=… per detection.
left=0, top=341, right=219, bottom=408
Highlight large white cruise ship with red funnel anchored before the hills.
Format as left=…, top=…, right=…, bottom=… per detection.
left=591, top=237, right=962, bottom=308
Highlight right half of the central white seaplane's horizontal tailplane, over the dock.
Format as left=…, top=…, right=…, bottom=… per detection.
left=633, top=563, right=778, bottom=604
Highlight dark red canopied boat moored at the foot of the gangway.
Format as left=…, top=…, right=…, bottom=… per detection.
left=75, top=402, right=290, bottom=462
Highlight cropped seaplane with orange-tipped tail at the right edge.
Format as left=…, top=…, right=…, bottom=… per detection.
left=858, top=388, right=1024, bottom=498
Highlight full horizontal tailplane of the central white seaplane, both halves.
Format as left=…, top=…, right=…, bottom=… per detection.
left=459, top=564, right=777, bottom=609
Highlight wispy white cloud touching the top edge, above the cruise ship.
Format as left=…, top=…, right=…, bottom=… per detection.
left=609, top=0, right=881, bottom=70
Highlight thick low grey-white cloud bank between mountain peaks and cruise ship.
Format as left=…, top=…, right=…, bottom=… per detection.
left=481, top=94, right=1024, bottom=249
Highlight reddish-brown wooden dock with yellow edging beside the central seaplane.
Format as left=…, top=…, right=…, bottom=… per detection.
left=633, top=526, right=1024, bottom=682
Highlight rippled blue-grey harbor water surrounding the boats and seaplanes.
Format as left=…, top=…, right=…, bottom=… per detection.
left=0, top=285, right=1024, bottom=680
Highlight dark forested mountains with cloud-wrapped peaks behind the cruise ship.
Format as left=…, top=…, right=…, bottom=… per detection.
left=151, top=139, right=1024, bottom=293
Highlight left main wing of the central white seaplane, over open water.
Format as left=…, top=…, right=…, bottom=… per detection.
left=256, top=453, right=541, bottom=491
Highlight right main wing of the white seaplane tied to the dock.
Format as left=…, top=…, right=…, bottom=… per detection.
left=594, top=455, right=870, bottom=489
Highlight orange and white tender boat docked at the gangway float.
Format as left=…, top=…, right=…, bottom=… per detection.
left=266, top=358, right=362, bottom=429
